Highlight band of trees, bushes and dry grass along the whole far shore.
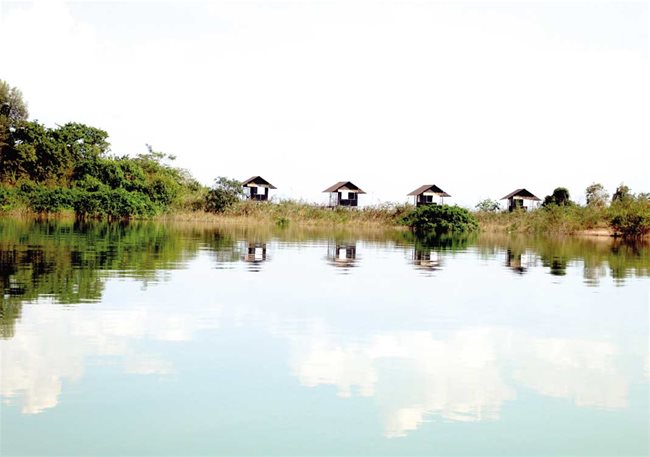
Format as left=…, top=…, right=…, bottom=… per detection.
left=0, top=80, right=650, bottom=238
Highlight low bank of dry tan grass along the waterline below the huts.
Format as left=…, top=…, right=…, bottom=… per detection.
left=0, top=200, right=650, bottom=239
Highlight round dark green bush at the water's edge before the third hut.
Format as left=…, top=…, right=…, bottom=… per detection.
left=402, top=205, right=478, bottom=235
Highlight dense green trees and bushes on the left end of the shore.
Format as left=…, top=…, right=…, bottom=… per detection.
left=0, top=81, right=205, bottom=218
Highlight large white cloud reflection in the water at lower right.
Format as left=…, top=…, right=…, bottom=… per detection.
left=292, top=327, right=630, bottom=437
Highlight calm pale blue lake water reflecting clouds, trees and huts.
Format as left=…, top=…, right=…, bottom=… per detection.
left=0, top=220, right=650, bottom=456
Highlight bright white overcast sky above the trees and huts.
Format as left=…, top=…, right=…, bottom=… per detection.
left=0, top=0, right=650, bottom=207
